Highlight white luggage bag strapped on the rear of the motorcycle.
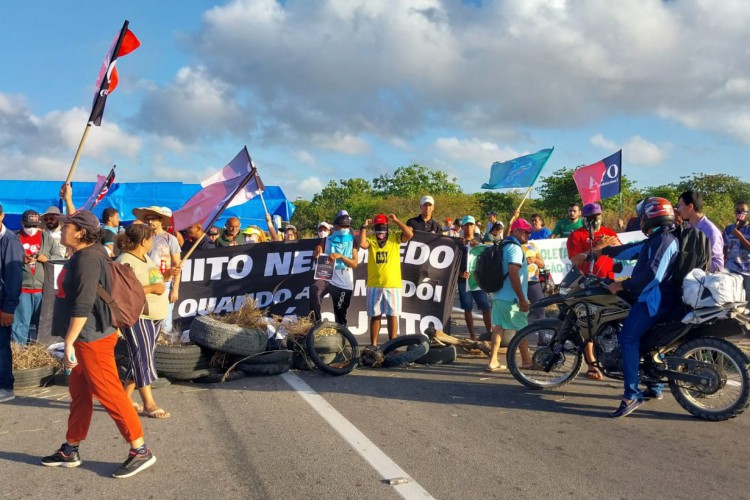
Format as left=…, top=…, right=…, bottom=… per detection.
left=682, top=269, right=745, bottom=309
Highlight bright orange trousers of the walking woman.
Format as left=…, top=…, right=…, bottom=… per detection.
left=65, top=332, right=143, bottom=443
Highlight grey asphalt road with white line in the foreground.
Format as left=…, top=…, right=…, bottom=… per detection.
left=0, top=314, right=750, bottom=499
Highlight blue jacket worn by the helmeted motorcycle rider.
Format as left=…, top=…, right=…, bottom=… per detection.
left=602, top=229, right=682, bottom=316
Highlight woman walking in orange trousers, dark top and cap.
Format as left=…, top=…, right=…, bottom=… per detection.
left=42, top=210, right=156, bottom=478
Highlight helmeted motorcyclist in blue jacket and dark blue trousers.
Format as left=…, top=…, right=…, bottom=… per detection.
left=594, top=197, right=681, bottom=417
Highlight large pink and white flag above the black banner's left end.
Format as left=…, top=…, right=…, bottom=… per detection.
left=172, top=147, right=265, bottom=231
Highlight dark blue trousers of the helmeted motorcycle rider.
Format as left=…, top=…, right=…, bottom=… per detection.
left=620, top=302, right=665, bottom=399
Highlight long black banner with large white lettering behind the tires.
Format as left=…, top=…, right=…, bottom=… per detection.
left=39, top=231, right=464, bottom=340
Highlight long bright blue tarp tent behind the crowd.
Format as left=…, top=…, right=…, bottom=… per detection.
left=0, top=181, right=294, bottom=229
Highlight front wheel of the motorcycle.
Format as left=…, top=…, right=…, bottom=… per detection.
left=508, top=324, right=583, bottom=390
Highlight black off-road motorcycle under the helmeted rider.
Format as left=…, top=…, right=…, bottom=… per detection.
left=508, top=267, right=750, bottom=420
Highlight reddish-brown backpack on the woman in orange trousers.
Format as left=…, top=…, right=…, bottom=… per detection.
left=97, top=259, right=148, bottom=328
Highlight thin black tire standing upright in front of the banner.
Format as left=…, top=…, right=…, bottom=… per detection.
left=307, top=321, right=359, bottom=376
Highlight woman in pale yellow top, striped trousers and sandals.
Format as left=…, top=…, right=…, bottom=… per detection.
left=117, top=224, right=171, bottom=418
